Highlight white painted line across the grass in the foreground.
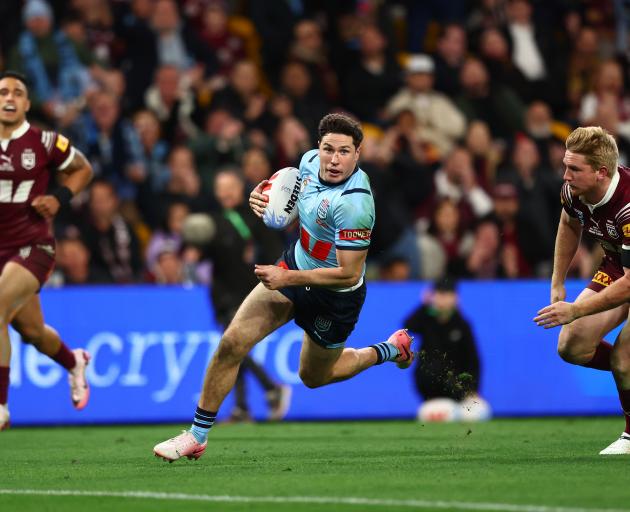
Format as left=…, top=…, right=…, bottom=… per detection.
left=0, top=489, right=630, bottom=512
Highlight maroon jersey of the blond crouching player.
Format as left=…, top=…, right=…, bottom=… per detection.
left=560, top=166, right=630, bottom=286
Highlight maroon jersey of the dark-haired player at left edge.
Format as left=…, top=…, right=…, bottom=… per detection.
left=0, top=122, right=74, bottom=249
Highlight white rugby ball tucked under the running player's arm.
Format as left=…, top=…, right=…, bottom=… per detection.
left=262, top=167, right=302, bottom=229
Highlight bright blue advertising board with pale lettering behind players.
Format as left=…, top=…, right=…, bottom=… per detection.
left=9, top=281, right=620, bottom=425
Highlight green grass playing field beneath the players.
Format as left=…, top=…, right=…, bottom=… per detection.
left=0, top=418, right=630, bottom=512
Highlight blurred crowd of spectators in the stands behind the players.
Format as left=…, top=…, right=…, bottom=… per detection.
left=0, top=0, right=630, bottom=285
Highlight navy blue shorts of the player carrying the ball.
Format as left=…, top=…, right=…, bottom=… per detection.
left=277, top=245, right=367, bottom=348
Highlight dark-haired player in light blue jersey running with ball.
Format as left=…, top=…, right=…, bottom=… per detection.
left=153, top=114, right=413, bottom=461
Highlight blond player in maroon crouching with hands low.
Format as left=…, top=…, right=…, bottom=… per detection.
left=534, top=126, right=630, bottom=455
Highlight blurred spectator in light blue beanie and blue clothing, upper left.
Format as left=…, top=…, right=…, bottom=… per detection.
left=7, top=0, right=91, bottom=123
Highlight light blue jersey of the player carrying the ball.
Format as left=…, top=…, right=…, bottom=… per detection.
left=295, top=149, right=375, bottom=282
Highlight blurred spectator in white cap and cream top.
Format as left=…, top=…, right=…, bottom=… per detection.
left=387, top=54, right=466, bottom=156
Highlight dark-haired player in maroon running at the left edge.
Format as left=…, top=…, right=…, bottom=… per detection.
left=0, top=72, right=92, bottom=430
